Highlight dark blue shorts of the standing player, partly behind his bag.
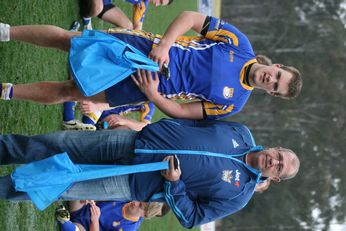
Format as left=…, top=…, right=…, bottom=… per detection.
left=105, top=30, right=153, bottom=107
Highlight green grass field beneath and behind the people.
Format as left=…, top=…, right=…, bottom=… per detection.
left=0, top=0, right=197, bottom=231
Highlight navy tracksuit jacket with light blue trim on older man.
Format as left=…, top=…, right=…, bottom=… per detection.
left=130, top=119, right=262, bottom=228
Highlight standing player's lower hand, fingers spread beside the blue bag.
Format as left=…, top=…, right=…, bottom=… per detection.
left=131, top=69, right=160, bottom=100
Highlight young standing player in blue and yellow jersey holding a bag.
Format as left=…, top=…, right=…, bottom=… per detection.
left=0, top=12, right=302, bottom=119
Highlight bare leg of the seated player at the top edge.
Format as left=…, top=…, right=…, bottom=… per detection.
left=98, top=4, right=133, bottom=29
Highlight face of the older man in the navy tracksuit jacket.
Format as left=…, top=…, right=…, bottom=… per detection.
left=252, top=148, right=296, bottom=181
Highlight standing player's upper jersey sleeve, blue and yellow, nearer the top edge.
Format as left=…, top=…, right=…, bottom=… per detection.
left=201, top=16, right=251, bottom=49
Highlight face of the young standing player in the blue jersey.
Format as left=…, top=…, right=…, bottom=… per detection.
left=250, top=64, right=293, bottom=96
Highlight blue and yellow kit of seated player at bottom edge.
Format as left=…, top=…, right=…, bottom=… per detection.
left=71, top=201, right=143, bottom=231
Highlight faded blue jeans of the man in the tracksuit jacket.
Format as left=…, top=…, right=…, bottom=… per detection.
left=0, top=130, right=137, bottom=200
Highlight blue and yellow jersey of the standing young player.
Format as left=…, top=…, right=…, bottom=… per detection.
left=159, top=17, right=256, bottom=119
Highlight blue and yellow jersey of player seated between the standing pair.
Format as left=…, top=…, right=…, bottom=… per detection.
left=99, top=102, right=155, bottom=123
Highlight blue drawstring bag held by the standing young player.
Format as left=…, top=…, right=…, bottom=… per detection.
left=69, top=30, right=159, bottom=96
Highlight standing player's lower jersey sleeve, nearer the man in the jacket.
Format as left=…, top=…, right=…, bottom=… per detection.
left=202, top=101, right=239, bottom=120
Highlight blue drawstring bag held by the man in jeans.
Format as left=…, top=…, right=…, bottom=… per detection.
left=11, top=152, right=168, bottom=210
